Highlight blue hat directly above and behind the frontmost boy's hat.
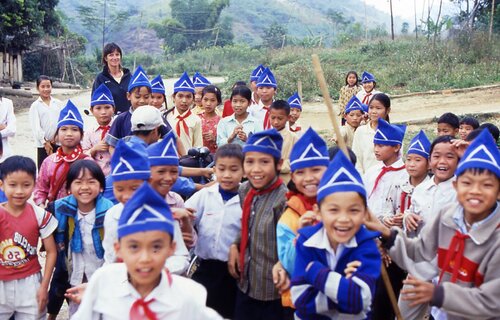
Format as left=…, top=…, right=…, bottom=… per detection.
left=111, top=140, right=151, bottom=181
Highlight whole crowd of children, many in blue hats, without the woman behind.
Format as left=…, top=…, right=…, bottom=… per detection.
left=0, top=45, right=500, bottom=320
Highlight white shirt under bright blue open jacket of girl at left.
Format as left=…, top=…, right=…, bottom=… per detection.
left=69, top=209, right=104, bottom=286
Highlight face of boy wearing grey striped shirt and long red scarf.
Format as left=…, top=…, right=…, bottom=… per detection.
left=243, top=151, right=282, bottom=190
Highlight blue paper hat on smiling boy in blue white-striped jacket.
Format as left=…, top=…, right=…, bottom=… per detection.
left=317, top=152, right=366, bottom=203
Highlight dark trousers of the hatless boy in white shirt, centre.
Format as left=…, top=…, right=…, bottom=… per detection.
left=192, top=260, right=237, bottom=318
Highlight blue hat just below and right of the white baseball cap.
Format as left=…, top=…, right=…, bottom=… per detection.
left=147, top=130, right=179, bottom=167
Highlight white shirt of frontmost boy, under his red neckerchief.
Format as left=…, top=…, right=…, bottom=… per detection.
left=71, top=263, right=222, bottom=320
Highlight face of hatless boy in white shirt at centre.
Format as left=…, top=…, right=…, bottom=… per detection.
left=215, top=157, right=243, bottom=192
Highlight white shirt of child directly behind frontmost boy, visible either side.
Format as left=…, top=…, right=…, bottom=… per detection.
left=102, top=203, right=189, bottom=274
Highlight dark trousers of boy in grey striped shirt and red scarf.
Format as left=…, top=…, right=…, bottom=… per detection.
left=233, top=289, right=286, bottom=320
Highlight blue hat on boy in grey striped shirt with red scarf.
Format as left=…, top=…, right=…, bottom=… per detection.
left=243, top=128, right=283, bottom=159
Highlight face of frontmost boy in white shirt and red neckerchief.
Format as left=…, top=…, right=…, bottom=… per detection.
left=115, top=230, right=175, bottom=297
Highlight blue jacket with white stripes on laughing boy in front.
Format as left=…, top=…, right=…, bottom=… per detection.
left=291, top=223, right=381, bottom=319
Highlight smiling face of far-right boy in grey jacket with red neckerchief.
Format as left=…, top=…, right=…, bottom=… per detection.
left=453, top=170, right=500, bottom=224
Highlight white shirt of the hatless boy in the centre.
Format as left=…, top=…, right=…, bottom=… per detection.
left=185, top=183, right=242, bottom=261
